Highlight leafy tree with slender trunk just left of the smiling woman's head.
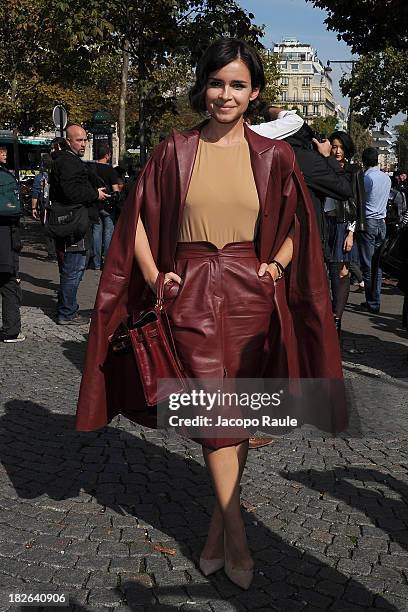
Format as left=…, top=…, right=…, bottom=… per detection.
left=55, top=0, right=263, bottom=162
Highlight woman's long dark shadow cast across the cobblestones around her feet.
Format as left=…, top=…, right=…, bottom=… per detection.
left=0, top=400, right=396, bottom=612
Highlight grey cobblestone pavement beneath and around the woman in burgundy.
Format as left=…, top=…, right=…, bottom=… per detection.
left=0, top=218, right=408, bottom=612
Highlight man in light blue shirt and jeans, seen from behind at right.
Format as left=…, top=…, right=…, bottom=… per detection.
left=357, top=147, right=391, bottom=314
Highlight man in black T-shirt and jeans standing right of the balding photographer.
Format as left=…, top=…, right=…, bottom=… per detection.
left=90, top=145, right=120, bottom=270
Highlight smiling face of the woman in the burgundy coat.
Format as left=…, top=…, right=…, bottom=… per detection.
left=205, top=59, right=259, bottom=123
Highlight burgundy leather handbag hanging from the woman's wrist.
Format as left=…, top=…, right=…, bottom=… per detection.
left=110, top=272, right=187, bottom=406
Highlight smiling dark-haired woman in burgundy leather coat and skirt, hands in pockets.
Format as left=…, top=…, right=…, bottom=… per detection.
left=77, top=38, right=346, bottom=588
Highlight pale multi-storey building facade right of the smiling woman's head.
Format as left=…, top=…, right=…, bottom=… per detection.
left=273, top=38, right=338, bottom=123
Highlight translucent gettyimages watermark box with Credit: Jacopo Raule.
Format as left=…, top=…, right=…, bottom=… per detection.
left=157, top=378, right=344, bottom=439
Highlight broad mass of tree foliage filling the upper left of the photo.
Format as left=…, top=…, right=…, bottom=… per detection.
left=0, top=0, right=275, bottom=152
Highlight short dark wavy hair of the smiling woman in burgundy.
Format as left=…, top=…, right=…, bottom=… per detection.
left=189, top=38, right=265, bottom=115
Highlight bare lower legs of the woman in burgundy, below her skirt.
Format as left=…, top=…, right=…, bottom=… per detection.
left=202, top=441, right=253, bottom=569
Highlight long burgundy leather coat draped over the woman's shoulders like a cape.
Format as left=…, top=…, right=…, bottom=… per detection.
left=76, top=126, right=347, bottom=431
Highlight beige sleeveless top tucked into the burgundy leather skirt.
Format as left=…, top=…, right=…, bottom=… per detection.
left=178, top=139, right=259, bottom=249
